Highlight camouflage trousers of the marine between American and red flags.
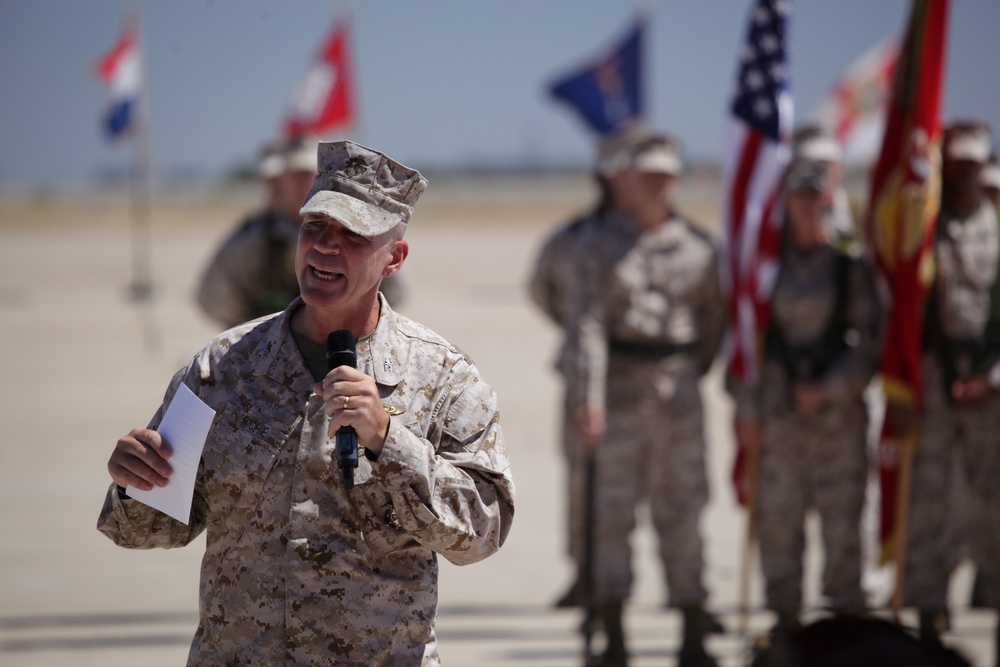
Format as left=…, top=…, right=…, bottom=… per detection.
left=757, top=400, right=868, bottom=613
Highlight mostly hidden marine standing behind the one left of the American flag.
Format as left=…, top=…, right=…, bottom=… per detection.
left=528, top=130, right=630, bottom=607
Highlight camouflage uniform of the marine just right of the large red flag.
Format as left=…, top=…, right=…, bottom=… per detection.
left=904, top=201, right=1000, bottom=610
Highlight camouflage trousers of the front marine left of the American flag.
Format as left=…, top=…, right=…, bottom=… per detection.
left=594, top=377, right=708, bottom=607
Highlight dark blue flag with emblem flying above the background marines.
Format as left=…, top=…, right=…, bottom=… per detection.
left=549, top=17, right=646, bottom=135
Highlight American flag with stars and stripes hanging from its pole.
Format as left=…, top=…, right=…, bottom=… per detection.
left=722, top=0, right=792, bottom=384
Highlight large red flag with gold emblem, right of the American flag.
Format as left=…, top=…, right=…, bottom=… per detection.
left=865, top=0, right=948, bottom=558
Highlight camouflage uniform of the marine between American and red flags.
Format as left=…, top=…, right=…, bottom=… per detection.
left=727, top=245, right=883, bottom=615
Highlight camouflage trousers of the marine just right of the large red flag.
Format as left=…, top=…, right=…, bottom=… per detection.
left=904, top=392, right=1000, bottom=609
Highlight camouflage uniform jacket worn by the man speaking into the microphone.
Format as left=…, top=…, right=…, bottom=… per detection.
left=98, top=299, right=514, bottom=666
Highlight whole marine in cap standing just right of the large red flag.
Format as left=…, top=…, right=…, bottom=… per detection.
left=904, top=121, right=1000, bottom=649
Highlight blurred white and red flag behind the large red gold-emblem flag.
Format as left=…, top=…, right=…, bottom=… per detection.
left=812, top=37, right=899, bottom=165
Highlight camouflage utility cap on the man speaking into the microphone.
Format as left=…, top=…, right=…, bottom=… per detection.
left=299, top=141, right=427, bottom=236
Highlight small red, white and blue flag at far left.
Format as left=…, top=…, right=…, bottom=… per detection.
left=97, top=15, right=142, bottom=139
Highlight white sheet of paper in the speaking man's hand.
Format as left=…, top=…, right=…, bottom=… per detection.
left=125, top=383, right=215, bottom=525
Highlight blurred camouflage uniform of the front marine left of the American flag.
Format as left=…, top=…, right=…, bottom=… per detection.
left=571, top=215, right=724, bottom=607
